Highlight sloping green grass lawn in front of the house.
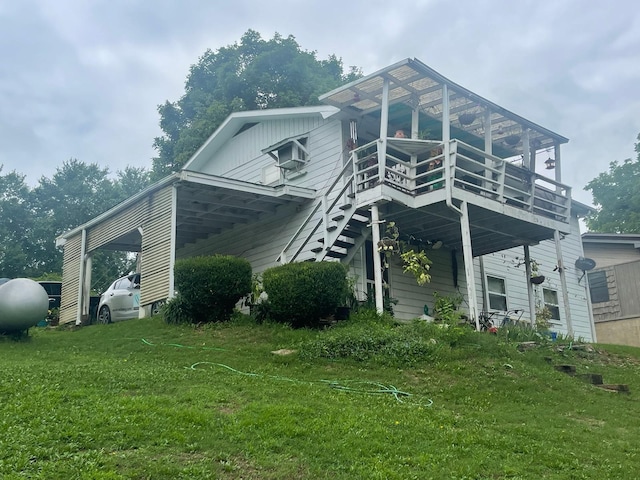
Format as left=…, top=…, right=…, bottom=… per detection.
left=0, top=317, right=640, bottom=480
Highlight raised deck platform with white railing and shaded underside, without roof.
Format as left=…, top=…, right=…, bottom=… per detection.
left=350, top=138, right=571, bottom=255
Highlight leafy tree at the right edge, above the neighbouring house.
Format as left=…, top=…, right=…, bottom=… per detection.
left=585, top=134, right=640, bottom=233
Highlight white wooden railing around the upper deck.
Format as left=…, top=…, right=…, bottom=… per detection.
left=351, top=138, right=571, bottom=223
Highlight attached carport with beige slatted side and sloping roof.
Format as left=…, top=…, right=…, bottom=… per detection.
left=56, top=170, right=315, bottom=325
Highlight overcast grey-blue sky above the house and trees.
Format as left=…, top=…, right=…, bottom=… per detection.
left=0, top=0, right=640, bottom=204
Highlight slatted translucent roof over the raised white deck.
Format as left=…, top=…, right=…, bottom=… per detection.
left=320, top=55, right=569, bottom=177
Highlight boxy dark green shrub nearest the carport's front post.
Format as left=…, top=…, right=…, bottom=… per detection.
left=170, top=255, right=251, bottom=323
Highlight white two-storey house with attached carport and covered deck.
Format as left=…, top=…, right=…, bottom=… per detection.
left=57, top=59, right=594, bottom=340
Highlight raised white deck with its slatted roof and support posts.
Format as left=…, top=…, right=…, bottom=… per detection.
left=320, top=59, right=572, bottom=334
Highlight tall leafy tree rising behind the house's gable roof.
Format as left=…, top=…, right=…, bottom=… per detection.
left=152, top=30, right=361, bottom=179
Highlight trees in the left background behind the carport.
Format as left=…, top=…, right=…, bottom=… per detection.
left=0, top=159, right=150, bottom=290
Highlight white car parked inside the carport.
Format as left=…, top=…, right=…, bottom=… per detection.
left=97, top=273, right=140, bottom=323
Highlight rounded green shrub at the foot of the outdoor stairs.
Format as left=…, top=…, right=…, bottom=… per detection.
left=262, top=262, right=348, bottom=327
